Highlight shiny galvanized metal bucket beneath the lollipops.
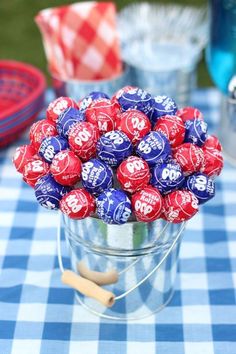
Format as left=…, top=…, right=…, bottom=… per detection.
left=59, top=216, right=185, bottom=320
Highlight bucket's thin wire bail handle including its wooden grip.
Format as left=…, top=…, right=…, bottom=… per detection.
left=57, top=212, right=186, bottom=307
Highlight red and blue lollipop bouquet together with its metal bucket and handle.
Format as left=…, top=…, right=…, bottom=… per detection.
left=13, top=86, right=223, bottom=319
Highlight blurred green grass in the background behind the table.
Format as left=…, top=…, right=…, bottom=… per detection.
left=0, top=0, right=213, bottom=87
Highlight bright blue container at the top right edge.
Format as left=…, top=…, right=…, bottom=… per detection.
left=206, top=0, right=236, bottom=93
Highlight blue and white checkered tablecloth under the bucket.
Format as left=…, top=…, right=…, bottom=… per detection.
left=0, top=89, right=236, bottom=354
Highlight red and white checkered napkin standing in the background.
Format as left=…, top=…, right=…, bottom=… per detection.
left=35, top=1, right=122, bottom=80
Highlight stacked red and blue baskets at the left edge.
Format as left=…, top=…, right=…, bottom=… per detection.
left=0, top=60, right=46, bottom=147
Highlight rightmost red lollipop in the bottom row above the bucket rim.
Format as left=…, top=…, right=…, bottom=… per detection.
left=163, top=190, right=198, bottom=224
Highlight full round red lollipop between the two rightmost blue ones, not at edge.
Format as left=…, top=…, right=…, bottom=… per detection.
left=173, top=143, right=204, bottom=176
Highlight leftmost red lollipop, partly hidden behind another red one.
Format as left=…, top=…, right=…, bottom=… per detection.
left=12, top=145, right=38, bottom=173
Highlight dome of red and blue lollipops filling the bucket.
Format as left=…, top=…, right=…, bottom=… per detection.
left=13, top=86, right=223, bottom=224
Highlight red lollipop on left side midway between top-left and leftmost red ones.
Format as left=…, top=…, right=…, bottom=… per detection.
left=29, top=119, right=58, bottom=151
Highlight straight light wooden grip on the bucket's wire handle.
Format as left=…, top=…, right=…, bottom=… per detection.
left=61, top=269, right=115, bottom=307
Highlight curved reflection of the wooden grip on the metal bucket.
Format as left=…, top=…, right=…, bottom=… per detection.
left=77, top=261, right=119, bottom=285
